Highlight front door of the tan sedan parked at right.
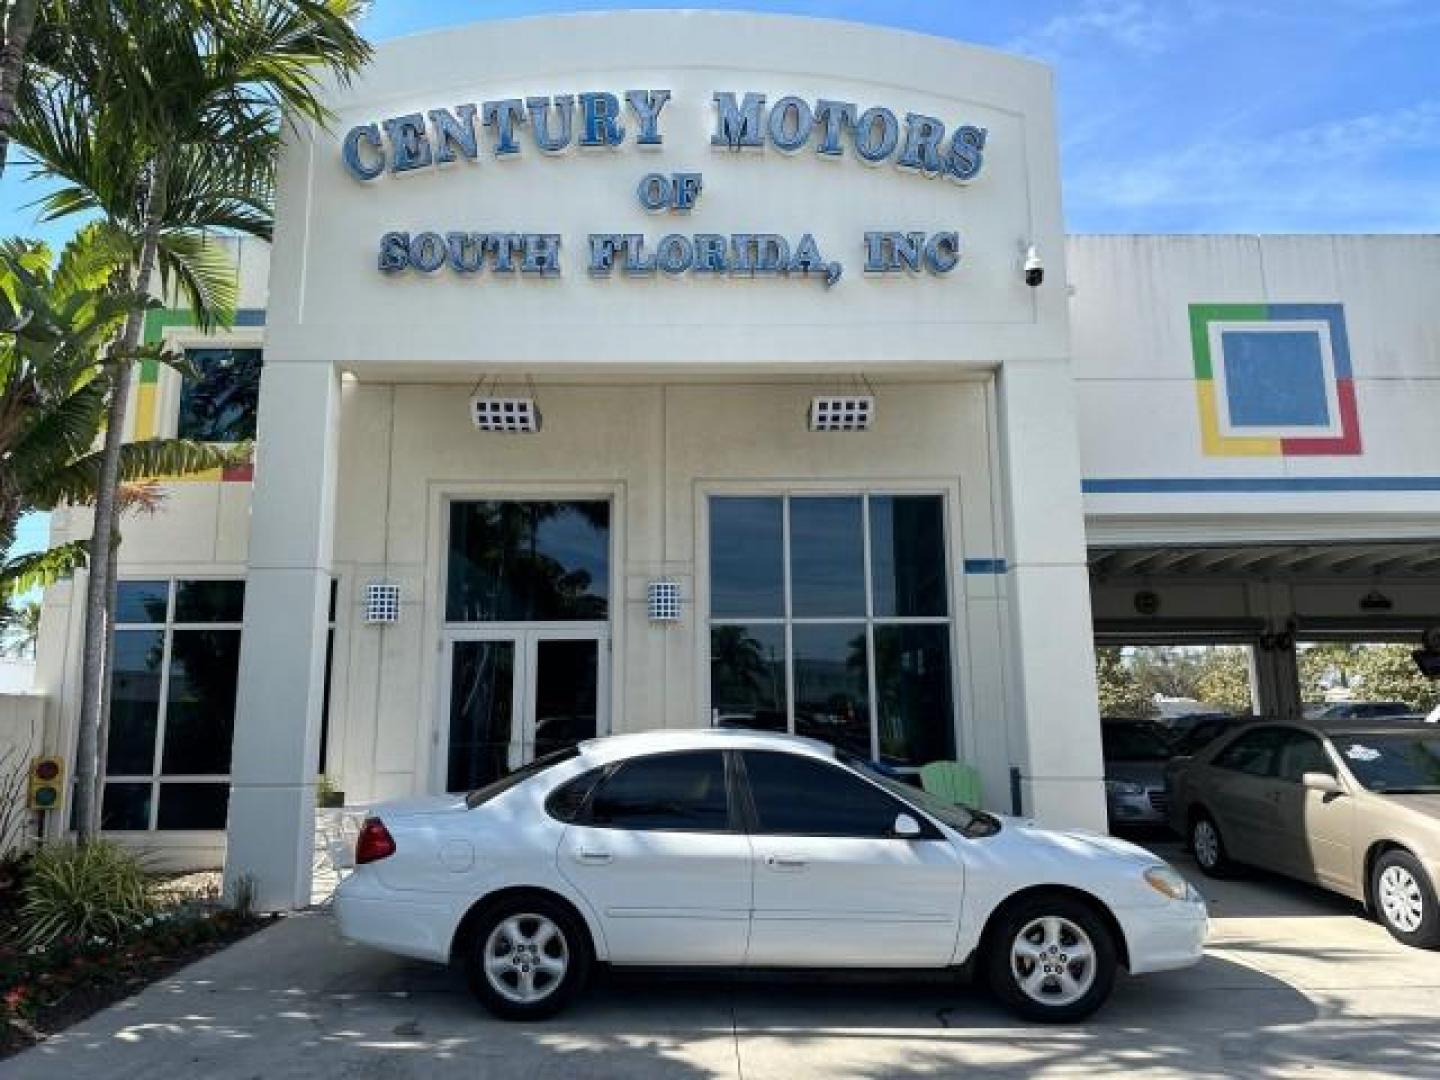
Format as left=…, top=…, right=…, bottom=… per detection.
left=1273, top=729, right=1354, bottom=888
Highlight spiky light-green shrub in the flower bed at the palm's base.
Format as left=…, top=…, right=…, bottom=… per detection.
left=20, top=841, right=156, bottom=946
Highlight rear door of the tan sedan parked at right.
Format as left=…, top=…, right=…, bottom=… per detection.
left=1201, top=727, right=1284, bottom=865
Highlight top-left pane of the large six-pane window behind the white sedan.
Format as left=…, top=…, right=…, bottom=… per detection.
left=710, top=497, right=785, bottom=619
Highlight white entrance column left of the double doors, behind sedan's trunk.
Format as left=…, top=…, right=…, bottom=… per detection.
left=225, top=361, right=340, bottom=910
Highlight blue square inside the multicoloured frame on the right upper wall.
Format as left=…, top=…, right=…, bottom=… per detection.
left=1220, top=330, right=1331, bottom=428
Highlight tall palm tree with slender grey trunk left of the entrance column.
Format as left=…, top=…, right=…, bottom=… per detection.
left=14, top=0, right=370, bottom=840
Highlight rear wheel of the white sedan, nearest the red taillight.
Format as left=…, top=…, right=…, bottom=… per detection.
left=464, top=894, right=595, bottom=1020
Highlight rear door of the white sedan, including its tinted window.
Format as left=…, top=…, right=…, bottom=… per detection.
left=557, top=750, right=752, bottom=965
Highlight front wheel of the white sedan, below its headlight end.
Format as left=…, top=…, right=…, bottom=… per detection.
left=984, top=893, right=1120, bottom=1024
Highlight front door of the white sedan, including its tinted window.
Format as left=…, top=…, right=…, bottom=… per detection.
left=739, top=750, right=965, bottom=968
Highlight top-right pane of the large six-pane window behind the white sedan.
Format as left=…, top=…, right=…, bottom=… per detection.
left=870, top=495, right=949, bottom=618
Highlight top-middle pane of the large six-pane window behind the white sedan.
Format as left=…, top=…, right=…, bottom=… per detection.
left=791, top=497, right=865, bottom=619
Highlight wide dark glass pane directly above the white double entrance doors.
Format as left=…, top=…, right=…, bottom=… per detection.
left=445, top=501, right=611, bottom=622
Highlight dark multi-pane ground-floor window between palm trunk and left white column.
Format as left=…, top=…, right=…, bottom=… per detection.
left=101, top=579, right=245, bottom=831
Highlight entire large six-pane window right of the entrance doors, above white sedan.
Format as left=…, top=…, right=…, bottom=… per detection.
left=710, top=494, right=955, bottom=769
